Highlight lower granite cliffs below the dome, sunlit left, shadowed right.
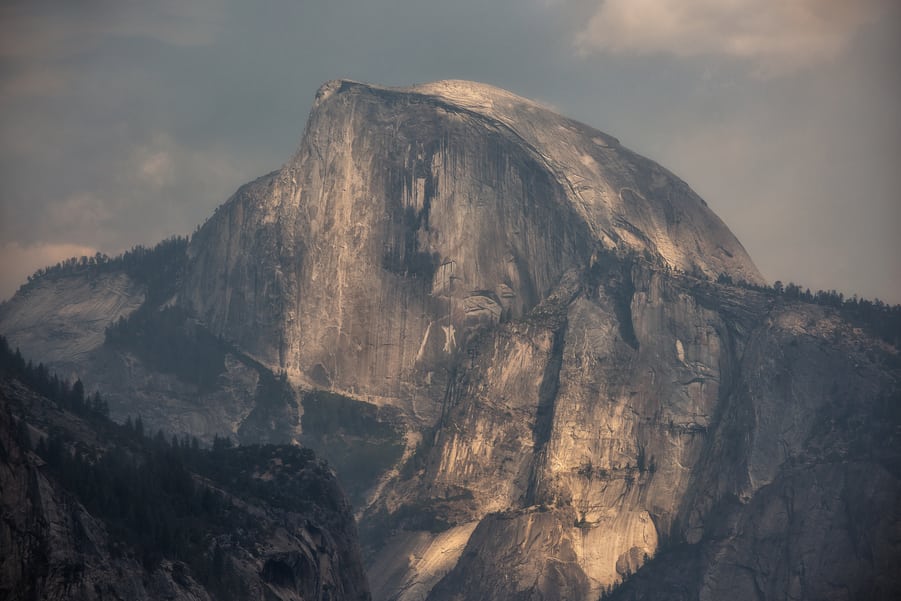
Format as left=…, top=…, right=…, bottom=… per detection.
left=364, top=260, right=901, bottom=600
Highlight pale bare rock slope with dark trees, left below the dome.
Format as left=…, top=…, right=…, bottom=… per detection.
left=0, top=257, right=299, bottom=443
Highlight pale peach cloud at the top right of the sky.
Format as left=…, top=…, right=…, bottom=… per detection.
left=576, top=0, right=892, bottom=76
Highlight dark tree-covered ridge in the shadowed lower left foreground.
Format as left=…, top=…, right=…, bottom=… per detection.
left=0, top=337, right=371, bottom=601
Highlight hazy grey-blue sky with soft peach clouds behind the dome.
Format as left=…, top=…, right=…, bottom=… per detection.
left=0, top=0, right=901, bottom=304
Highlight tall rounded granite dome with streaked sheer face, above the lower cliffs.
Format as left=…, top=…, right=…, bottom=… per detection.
left=184, top=82, right=760, bottom=418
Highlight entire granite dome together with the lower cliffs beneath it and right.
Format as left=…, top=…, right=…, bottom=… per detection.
left=0, top=81, right=901, bottom=601
